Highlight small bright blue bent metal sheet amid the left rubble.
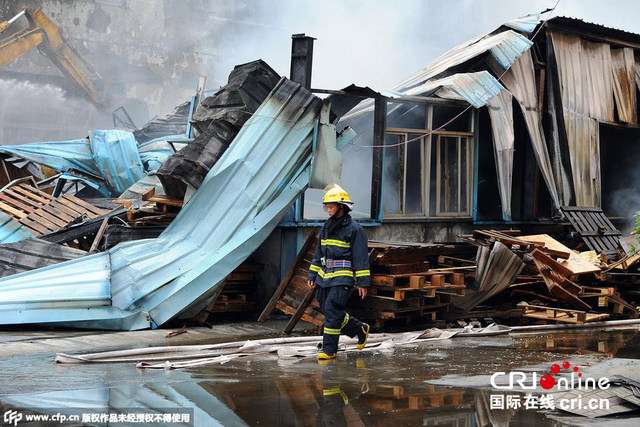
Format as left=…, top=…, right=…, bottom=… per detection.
left=89, top=129, right=144, bottom=194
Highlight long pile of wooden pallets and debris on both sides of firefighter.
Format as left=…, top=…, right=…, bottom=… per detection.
left=260, top=226, right=640, bottom=332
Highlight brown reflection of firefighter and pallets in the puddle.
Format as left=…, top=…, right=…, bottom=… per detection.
left=196, top=357, right=551, bottom=427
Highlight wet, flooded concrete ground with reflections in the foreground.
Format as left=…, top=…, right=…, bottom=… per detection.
left=0, top=326, right=640, bottom=426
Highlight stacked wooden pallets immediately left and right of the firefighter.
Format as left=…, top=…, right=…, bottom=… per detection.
left=259, top=233, right=473, bottom=332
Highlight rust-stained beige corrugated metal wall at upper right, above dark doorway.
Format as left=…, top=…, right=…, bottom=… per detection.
left=550, top=31, right=637, bottom=207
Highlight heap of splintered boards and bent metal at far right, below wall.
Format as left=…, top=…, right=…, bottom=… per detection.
left=458, top=230, right=639, bottom=323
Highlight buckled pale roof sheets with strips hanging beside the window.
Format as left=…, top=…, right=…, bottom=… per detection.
left=345, top=10, right=560, bottom=220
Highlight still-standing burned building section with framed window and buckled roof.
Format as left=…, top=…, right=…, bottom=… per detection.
left=288, top=15, right=640, bottom=241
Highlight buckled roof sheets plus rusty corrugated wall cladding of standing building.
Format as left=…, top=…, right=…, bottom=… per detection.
left=345, top=10, right=640, bottom=220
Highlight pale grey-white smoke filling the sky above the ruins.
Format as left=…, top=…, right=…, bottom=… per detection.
left=0, top=0, right=640, bottom=176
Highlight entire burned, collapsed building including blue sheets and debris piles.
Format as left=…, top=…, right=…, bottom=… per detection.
left=0, top=10, right=640, bottom=329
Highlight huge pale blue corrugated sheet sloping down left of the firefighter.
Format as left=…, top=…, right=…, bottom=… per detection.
left=0, top=78, right=321, bottom=329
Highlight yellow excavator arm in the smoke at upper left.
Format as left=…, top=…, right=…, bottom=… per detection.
left=0, top=7, right=106, bottom=106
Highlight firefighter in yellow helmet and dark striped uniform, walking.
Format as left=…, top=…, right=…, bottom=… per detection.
left=307, top=184, right=371, bottom=360
